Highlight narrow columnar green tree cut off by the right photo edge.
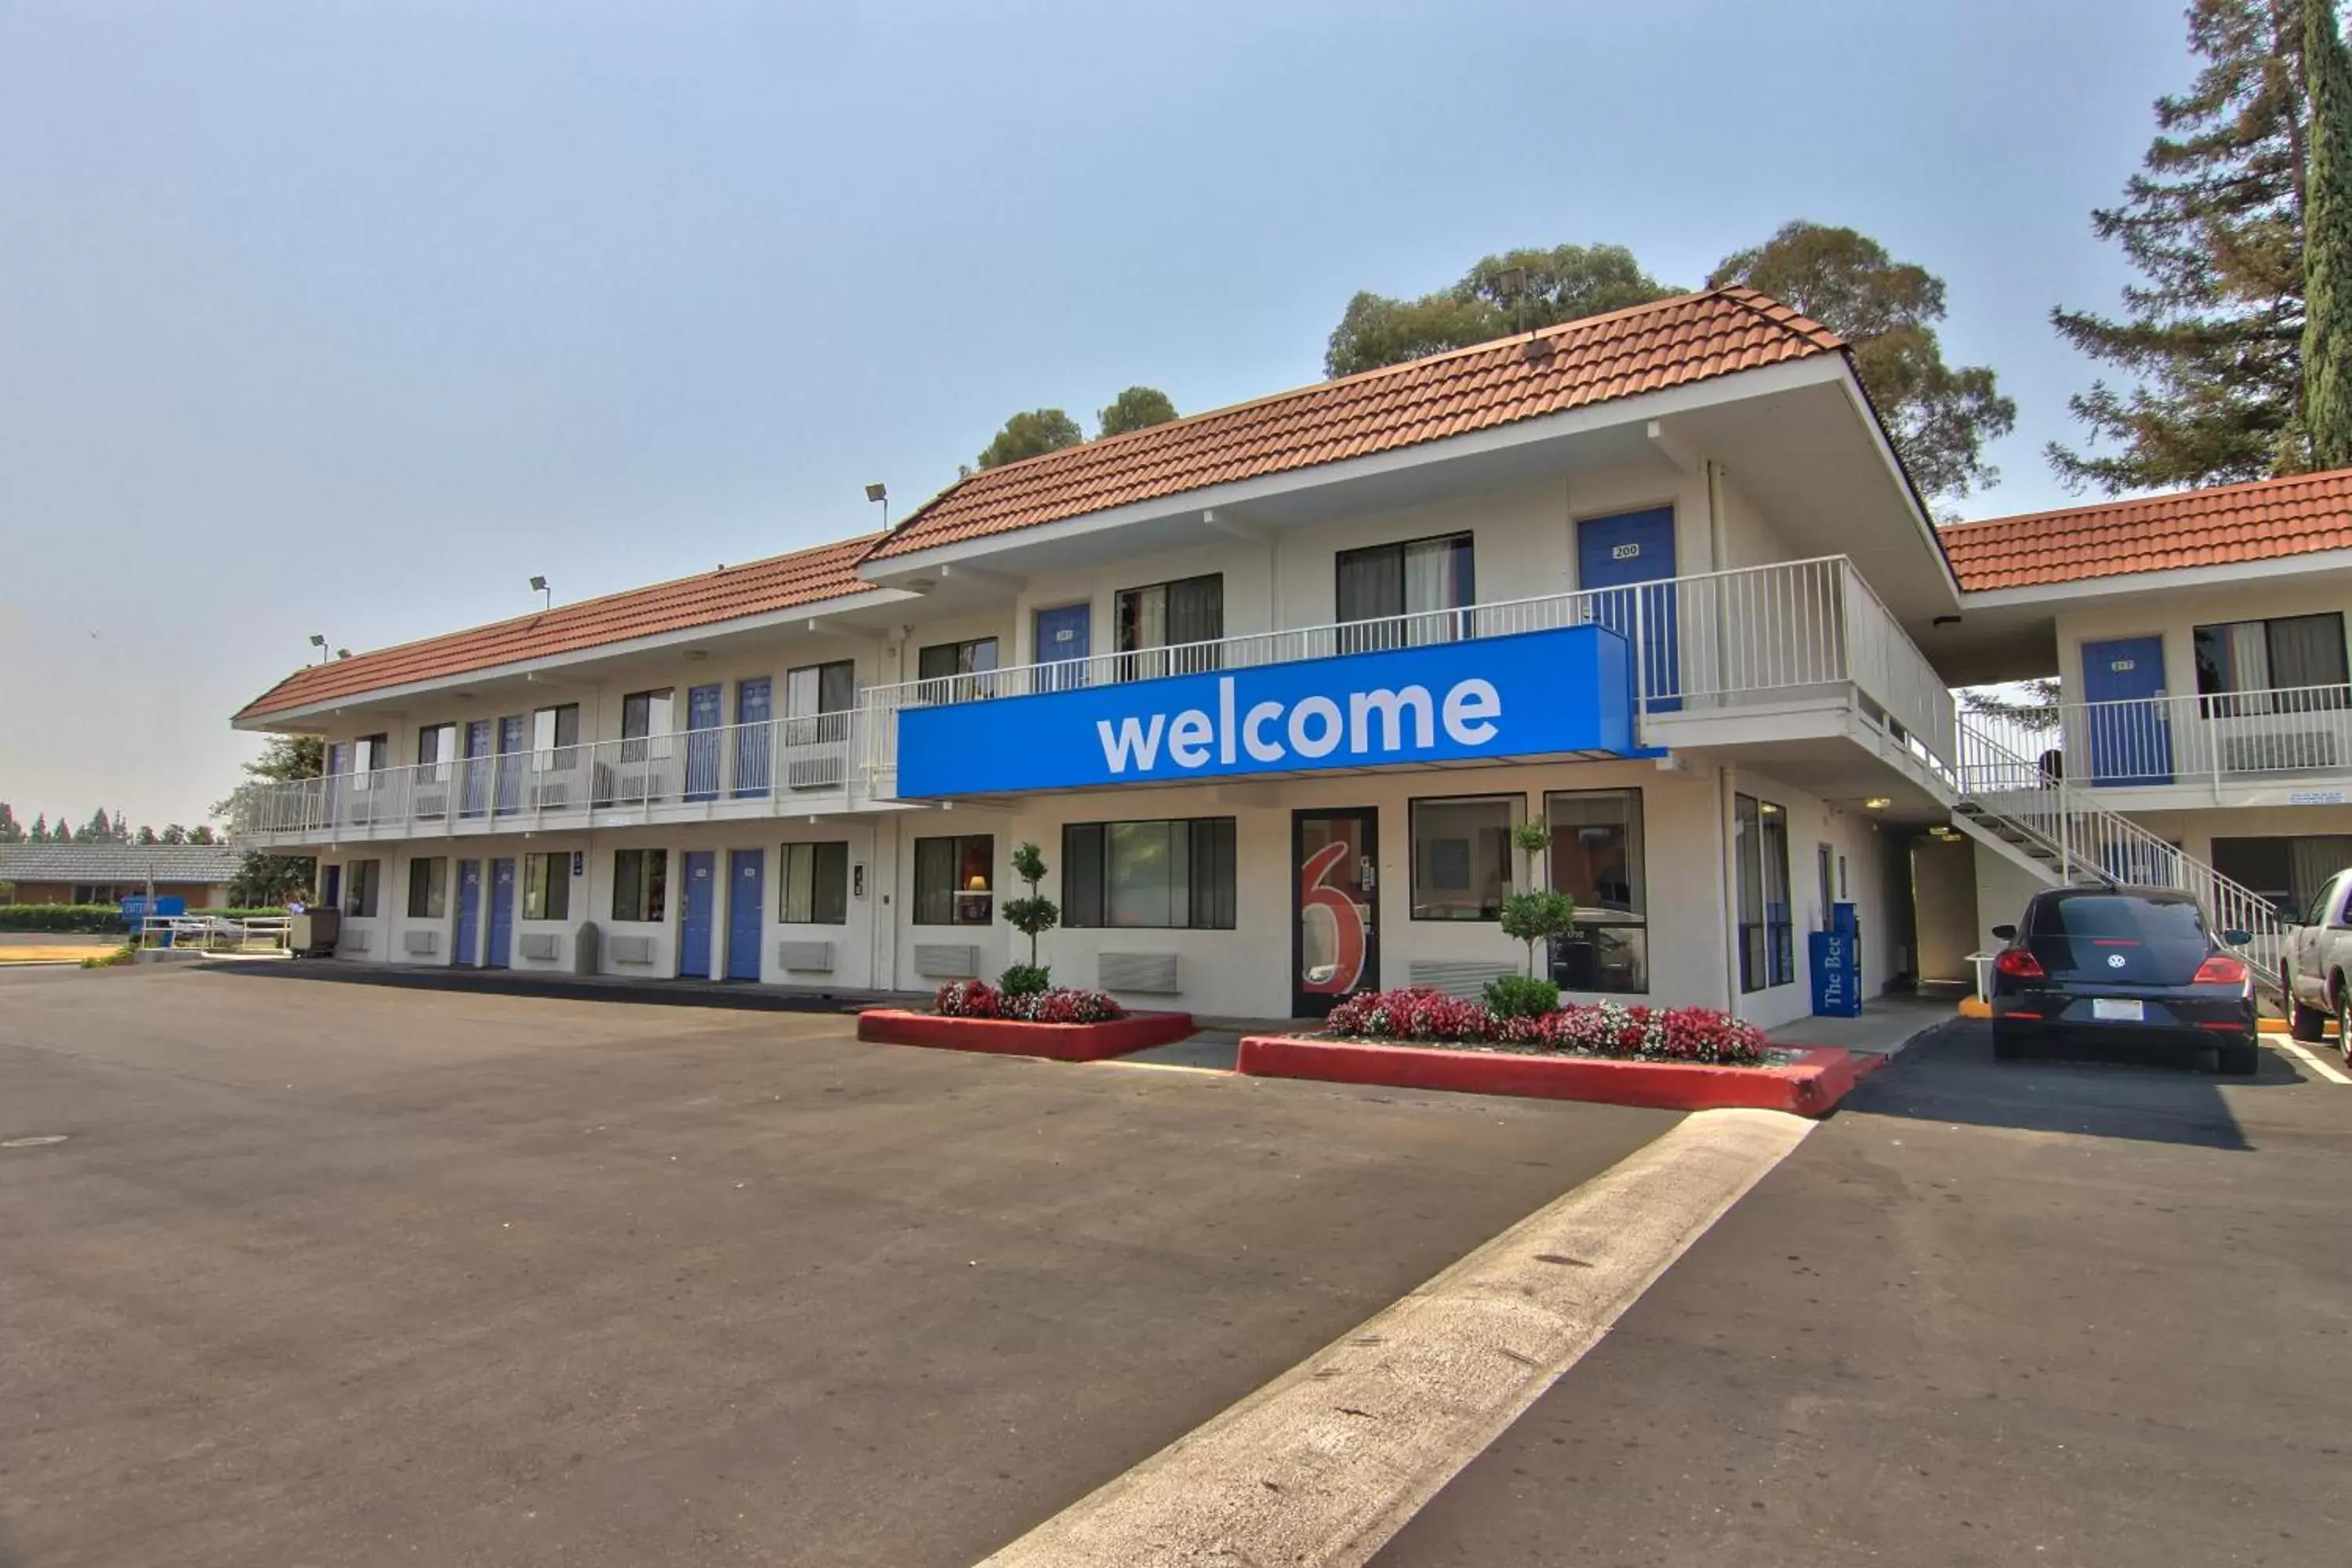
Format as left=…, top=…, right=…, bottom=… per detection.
left=2303, top=0, right=2352, bottom=468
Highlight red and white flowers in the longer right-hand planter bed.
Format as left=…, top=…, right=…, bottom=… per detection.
left=1324, top=987, right=1771, bottom=1067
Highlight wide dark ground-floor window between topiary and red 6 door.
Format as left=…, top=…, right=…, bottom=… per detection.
left=1061, top=815, right=1235, bottom=931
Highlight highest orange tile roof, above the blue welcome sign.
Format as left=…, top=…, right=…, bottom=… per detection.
left=873, top=287, right=1844, bottom=560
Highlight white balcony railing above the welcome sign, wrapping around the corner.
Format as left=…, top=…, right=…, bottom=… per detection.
left=858, top=555, right=1955, bottom=781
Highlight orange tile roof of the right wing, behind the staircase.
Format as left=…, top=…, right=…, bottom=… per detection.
left=1940, top=468, right=2352, bottom=593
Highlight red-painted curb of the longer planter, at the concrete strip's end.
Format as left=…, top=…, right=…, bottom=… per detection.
left=1235, top=1034, right=1860, bottom=1116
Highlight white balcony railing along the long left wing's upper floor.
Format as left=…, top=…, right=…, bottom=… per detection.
left=233, top=710, right=861, bottom=837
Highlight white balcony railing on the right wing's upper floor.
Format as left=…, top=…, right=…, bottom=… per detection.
left=2020, top=687, right=2352, bottom=789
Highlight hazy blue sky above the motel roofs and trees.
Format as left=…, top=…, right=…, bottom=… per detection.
left=0, top=0, right=2190, bottom=825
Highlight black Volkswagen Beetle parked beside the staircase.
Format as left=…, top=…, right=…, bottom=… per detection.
left=1992, top=886, right=2260, bottom=1074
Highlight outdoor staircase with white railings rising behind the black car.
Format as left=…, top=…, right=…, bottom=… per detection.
left=1952, top=713, right=2286, bottom=1001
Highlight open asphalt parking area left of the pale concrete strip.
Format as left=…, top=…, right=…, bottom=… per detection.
left=0, top=971, right=1675, bottom=1568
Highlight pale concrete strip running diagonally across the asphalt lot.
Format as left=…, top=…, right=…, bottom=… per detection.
left=964, top=1109, right=1813, bottom=1568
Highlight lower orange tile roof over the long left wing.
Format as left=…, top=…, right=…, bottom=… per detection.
left=238, top=534, right=880, bottom=720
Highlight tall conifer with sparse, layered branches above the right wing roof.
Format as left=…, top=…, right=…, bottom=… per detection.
left=2046, top=0, right=2326, bottom=494
